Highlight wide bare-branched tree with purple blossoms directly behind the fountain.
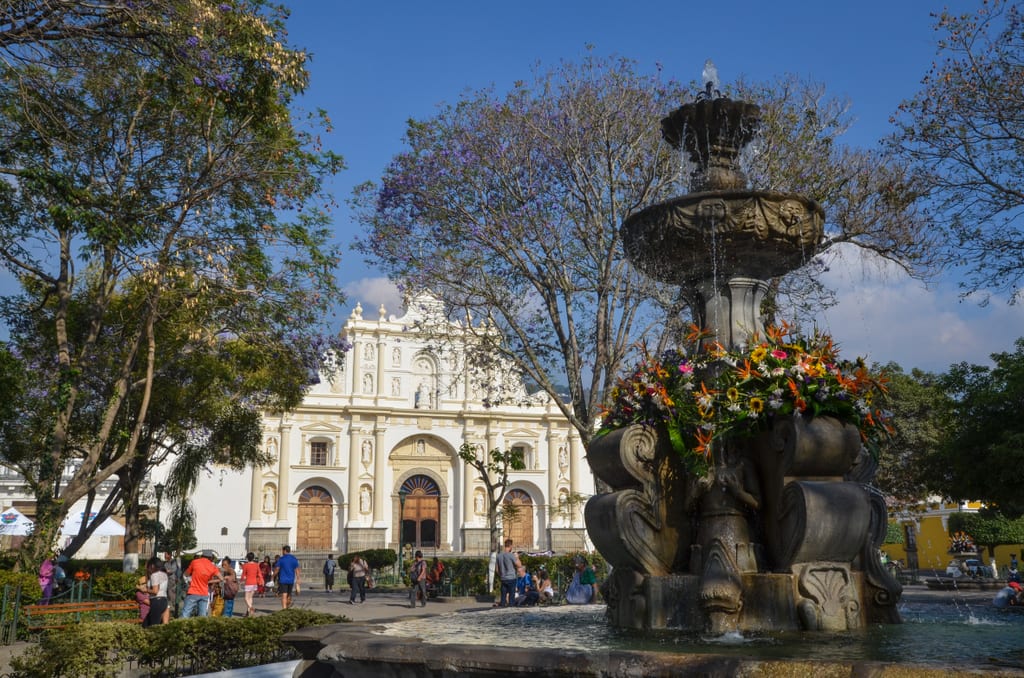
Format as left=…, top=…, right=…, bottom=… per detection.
left=353, top=56, right=928, bottom=454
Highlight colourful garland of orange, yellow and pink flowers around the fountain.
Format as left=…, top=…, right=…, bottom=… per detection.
left=598, top=324, right=892, bottom=473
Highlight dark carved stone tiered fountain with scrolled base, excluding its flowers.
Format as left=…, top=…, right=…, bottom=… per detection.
left=586, top=83, right=901, bottom=634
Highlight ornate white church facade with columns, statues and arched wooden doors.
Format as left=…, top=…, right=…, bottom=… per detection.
left=194, top=295, right=594, bottom=555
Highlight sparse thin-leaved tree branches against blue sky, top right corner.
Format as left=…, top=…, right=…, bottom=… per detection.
left=891, top=0, right=1024, bottom=302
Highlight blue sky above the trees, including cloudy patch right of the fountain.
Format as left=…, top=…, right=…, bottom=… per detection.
left=289, top=0, right=1024, bottom=371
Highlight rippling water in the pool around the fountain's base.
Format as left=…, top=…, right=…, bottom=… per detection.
left=381, top=593, right=1024, bottom=670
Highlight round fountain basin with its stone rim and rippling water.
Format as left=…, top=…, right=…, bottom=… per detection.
left=286, top=587, right=1024, bottom=678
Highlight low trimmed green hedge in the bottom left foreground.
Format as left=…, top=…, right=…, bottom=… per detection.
left=11, top=609, right=343, bottom=678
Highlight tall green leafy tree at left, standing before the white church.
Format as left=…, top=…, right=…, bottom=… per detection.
left=0, top=0, right=341, bottom=563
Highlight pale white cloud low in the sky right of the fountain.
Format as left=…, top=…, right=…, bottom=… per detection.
left=820, top=246, right=1024, bottom=372
